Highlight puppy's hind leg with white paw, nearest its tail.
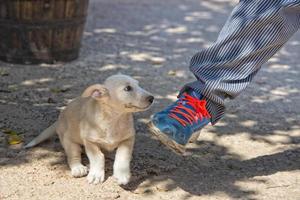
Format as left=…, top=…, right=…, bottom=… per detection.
left=63, top=140, right=88, bottom=177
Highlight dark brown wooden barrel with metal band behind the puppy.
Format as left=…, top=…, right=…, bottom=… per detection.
left=0, top=0, right=88, bottom=64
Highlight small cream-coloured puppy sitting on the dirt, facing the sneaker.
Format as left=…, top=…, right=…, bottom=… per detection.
left=25, top=75, right=154, bottom=184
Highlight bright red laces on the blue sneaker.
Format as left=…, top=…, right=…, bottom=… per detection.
left=169, top=93, right=211, bottom=126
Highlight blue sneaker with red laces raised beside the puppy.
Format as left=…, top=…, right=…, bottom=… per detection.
left=149, top=91, right=211, bottom=154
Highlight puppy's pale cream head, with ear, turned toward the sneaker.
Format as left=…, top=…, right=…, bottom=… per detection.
left=82, top=74, right=154, bottom=112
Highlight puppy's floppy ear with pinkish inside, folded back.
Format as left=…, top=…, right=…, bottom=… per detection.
left=81, top=84, right=109, bottom=100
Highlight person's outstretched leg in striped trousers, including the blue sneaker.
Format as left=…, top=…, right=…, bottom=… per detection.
left=150, top=0, right=300, bottom=153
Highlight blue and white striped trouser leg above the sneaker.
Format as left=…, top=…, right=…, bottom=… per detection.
left=181, top=0, right=300, bottom=124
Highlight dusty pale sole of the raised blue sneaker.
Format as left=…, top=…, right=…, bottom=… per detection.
left=147, top=121, right=186, bottom=155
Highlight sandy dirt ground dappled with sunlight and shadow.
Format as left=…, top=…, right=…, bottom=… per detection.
left=0, top=0, right=300, bottom=200
